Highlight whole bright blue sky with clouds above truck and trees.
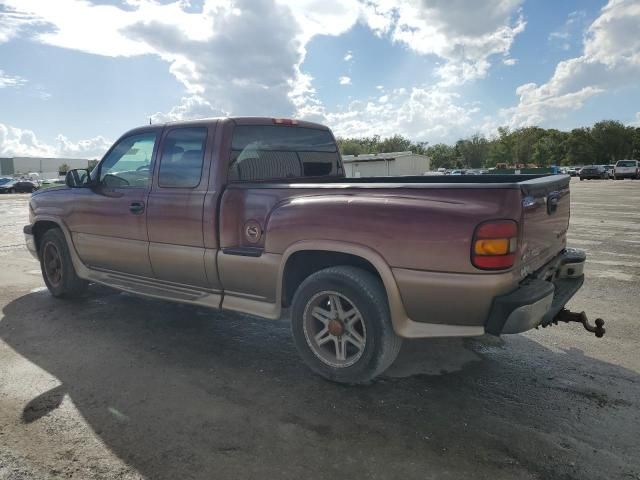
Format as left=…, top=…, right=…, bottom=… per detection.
left=0, top=0, right=640, bottom=158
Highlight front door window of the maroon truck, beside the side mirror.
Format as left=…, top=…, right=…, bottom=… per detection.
left=100, top=132, right=157, bottom=188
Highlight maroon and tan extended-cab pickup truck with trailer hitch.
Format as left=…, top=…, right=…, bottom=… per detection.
left=24, top=117, right=604, bottom=383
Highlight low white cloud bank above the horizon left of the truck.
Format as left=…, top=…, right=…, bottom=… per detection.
left=0, top=123, right=111, bottom=158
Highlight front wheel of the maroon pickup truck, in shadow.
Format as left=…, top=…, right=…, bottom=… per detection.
left=38, top=228, right=89, bottom=298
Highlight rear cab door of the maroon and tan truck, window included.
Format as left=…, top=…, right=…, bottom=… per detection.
left=147, top=124, right=220, bottom=293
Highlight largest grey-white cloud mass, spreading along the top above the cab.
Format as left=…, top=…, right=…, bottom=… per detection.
left=0, top=0, right=524, bottom=127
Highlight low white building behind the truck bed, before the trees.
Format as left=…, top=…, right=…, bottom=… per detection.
left=342, top=152, right=431, bottom=178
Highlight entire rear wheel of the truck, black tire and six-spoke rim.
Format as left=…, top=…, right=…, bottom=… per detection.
left=291, top=266, right=402, bottom=384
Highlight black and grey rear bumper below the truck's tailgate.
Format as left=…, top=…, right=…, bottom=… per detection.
left=485, top=249, right=586, bottom=335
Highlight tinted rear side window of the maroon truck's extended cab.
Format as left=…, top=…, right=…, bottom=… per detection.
left=158, top=127, right=207, bottom=188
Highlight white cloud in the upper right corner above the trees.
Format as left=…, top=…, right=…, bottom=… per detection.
left=501, top=0, right=640, bottom=126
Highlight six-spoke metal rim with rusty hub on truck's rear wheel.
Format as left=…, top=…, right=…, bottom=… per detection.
left=303, top=291, right=367, bottom=368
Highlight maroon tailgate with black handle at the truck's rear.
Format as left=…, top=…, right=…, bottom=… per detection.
left=519, top=175, right=571, bottom=274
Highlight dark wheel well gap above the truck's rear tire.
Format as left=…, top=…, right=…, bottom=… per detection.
left=282, top=250, right=381, bottom=307
